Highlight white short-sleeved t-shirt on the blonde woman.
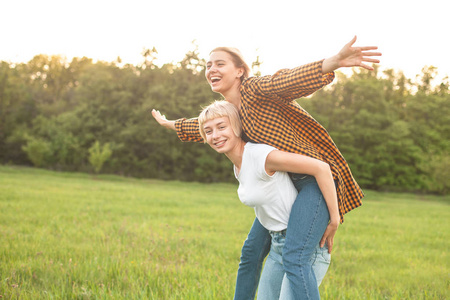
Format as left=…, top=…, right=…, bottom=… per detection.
left=234, top=143, right=298, bottom=231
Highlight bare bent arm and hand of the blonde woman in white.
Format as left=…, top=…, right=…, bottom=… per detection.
left=265, top=150, right=340, bottom=253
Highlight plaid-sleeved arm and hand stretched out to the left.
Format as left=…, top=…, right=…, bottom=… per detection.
left=152, top=109, right=203, bottom=143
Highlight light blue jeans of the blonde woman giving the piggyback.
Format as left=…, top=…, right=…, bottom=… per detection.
left=257, top=232, right=331, bottom=300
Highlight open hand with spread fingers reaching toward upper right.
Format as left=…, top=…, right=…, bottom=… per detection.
left=322, top=36, right=381, bottom=74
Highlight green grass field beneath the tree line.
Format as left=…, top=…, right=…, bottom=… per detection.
left=0, top=166, right=450, bottom=299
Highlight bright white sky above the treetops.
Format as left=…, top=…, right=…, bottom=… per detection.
left=0, top=0, right=450, bottom=79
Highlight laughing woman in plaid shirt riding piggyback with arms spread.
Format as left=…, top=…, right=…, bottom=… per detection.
left=152, top=37, right=381, bottom=299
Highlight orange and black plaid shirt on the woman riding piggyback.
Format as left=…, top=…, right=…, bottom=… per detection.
left=175, top=61, right=364, bottom=222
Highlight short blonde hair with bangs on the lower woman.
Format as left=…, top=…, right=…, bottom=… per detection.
left=198, top=100, right=242, bottom=143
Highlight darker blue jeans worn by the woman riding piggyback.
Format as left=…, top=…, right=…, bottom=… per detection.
left=234, top=175, right=329, bottom=300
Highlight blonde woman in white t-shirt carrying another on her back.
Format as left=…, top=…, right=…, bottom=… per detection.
left=198, top=101, right=338, bottom=299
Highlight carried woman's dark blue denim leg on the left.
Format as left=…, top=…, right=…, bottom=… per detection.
left=234, top=218, right=271, bottom=300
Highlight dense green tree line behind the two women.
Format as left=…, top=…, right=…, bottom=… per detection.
left=0, top=48, right=450, bottom=194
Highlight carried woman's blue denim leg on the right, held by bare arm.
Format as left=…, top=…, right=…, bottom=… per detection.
left=280, top=176, right=330, bottom=299
